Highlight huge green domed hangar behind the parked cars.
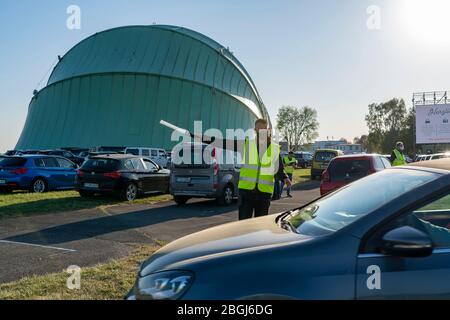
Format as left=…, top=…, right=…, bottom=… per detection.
left=16, top=25, right=269, bottom=150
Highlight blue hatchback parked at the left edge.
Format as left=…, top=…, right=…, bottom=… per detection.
left=0, top=155, right=78, bottom=193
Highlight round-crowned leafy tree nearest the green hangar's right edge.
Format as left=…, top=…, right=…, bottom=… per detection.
left=277, top=106, right=319, bottom=151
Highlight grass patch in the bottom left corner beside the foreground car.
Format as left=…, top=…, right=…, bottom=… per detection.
left=0, top=246, right=159, bottom=300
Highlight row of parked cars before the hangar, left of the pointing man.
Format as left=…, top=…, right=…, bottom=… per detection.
left=0, top=145, right=240, bottom=205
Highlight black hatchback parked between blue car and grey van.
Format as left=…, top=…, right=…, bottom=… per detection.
left=76, top=154, right=170, bottom=201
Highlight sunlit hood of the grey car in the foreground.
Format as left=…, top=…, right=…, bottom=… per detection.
left=140, top=215, right=309, bottom=276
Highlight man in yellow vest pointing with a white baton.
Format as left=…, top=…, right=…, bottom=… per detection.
left=239, top=119, right=291, bottom=220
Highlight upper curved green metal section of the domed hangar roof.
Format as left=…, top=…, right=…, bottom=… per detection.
left=48, top=25, right=269, bottom=119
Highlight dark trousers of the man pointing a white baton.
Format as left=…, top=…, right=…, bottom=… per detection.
left=239, top=190, right=272, bottom=220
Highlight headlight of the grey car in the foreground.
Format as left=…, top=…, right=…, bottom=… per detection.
left=135, top=271, right=194, bottom=300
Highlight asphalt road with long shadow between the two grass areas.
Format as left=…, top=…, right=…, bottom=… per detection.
left=0, top=182, right=319, bottom=283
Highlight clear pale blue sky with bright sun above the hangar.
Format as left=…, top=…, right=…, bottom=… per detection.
left=0, top=0, right=450, bottom=151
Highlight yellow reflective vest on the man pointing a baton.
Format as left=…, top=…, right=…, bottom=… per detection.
left=239, top=139, right=280, bottom=194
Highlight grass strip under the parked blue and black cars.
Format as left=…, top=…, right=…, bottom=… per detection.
left=0, top=191, right=172, bottom=220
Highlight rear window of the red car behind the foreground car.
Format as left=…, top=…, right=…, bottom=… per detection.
left=328, top=159, right=370, bottom=181
